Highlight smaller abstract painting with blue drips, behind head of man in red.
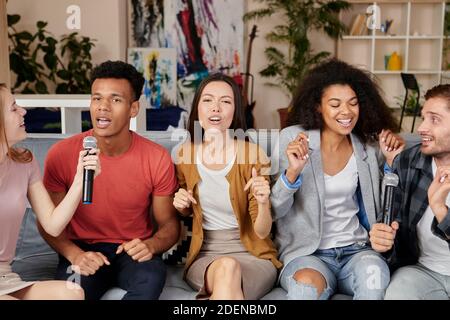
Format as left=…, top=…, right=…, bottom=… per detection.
left=128, top=48, right=177, bottom=109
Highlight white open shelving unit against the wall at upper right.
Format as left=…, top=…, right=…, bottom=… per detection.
left=337, top=0, right=450, bottom=108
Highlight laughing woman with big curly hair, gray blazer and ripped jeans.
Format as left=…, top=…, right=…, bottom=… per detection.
left=271, top=59, right=404, bottom=299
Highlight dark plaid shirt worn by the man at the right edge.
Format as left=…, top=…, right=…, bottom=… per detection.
left=389, top=144, right=450, bottom=269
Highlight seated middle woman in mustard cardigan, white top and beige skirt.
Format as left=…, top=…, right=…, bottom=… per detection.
left=173, top=74, right=281, bottom=300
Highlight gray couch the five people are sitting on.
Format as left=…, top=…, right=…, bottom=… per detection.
left=12, top=132, right=417, bottom=300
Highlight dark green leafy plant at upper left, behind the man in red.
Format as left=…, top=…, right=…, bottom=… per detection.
left=8, top=14, right=95, bottom=94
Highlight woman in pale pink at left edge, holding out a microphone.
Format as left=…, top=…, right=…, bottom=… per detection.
left=0, top=84, right=100, bottom=300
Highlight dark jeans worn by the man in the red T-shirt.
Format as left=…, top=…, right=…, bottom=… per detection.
left=56, top=241, right=166, bottom=300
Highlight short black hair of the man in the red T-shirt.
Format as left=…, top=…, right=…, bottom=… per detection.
left=91, top=60, right=145, bottom=101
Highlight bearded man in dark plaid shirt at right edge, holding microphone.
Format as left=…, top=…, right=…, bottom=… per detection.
left=370, top=84, right=450, bottom=300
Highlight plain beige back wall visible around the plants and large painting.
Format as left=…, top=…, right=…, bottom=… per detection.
left=7, top=0, right=334, bottom=128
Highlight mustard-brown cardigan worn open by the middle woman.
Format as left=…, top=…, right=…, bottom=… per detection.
left=176, top=140, right=282, bottom=271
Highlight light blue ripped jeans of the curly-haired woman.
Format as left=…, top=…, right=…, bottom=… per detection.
left=280, top=243, right=390, bottom=300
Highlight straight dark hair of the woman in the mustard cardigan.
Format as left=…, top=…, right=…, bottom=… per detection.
left=188, top=72, right=247, bottom=139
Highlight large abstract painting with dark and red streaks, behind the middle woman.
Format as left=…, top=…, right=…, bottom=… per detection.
left=129, top=0, right=245, bottom=111
